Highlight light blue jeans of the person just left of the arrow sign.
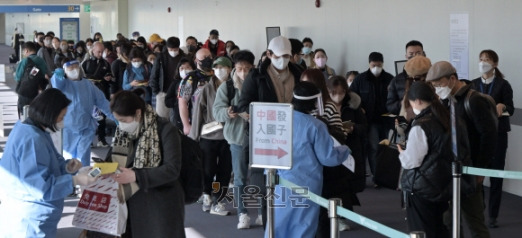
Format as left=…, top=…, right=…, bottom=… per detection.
left=230, top=144, right=248, bottom=215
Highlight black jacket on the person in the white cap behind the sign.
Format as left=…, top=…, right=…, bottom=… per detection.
left=238, top=58, right=302, bottom=112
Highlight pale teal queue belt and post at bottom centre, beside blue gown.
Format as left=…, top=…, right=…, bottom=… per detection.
left=279, top=177, right=418, bottom=238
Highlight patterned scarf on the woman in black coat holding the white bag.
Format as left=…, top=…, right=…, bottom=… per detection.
left=113, top=105, right=161, bottom=169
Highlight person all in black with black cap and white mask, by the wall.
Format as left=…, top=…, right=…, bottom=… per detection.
left=350, top=52, right=393, bottom=183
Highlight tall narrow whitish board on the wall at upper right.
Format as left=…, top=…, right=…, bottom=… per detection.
left=450, top=13, right=469, bottom=79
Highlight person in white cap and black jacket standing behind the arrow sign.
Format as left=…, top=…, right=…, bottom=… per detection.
left=237, top=36, right=302, bottom=229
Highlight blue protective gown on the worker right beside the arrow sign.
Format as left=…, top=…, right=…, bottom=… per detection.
left=265, top=111, right=351, bottom=238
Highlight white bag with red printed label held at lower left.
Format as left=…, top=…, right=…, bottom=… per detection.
left=72, top=177, right=128, bottom=236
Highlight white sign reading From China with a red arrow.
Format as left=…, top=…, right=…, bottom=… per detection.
left=250, top=102, right=293, bottom=169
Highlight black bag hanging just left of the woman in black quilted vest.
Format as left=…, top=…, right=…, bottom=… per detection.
left=374, top=130, right=402, bottom=190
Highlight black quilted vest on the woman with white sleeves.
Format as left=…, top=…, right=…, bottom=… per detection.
left=401, top=108, right=453, bottom=202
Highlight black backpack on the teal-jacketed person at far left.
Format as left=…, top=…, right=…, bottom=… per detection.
left=15, top=58, right=48, bottom=98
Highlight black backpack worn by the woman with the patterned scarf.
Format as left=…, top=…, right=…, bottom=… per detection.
left=178, top=130, right=203, bottom=204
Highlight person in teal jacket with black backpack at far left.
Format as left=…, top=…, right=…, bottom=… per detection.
left=15, top=42, right=48, bottom=117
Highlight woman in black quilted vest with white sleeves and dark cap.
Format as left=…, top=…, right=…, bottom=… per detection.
left=397, top=82, right=453, bottom=237
